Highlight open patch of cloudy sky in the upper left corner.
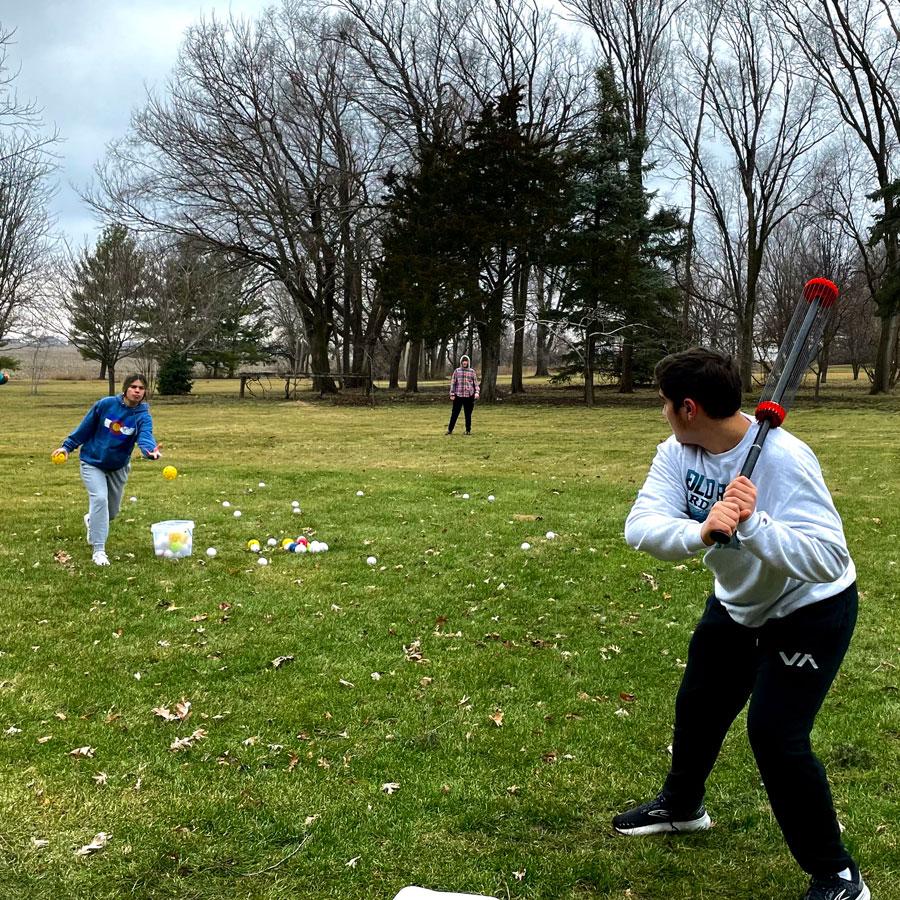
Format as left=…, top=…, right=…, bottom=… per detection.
left=0, top=0, right=270, bottom=245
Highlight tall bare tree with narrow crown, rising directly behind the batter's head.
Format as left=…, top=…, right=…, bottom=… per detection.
left=677, top=0, right=823, bottom=390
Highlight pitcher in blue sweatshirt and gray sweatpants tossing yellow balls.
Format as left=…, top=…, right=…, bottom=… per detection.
left=53, top=375, right=161, bottom=566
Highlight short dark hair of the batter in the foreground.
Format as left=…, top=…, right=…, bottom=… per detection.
left=654, top=347, right=741, bottom=419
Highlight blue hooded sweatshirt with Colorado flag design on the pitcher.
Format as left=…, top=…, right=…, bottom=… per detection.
left=62, top=394, right=156, bottom=472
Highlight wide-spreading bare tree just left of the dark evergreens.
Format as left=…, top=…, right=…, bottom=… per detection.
left=89, top=2, right=388, bottom=391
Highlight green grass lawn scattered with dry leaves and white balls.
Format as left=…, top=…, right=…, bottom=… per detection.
left=0, top=382, right=900, bottom=900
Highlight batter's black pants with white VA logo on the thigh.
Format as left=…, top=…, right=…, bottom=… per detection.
left=664, top=584, right=858, bottom=876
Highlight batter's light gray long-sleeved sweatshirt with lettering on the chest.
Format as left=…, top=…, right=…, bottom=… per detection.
left=625, top=416, right=856, bottom=627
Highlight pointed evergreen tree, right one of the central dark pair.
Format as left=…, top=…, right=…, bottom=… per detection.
left=547, top=69, right=683, bottom=404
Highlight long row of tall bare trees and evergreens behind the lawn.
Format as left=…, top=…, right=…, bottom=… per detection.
left=0, top=0, right=900, bottom=402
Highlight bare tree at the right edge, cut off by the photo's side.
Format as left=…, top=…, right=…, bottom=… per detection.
left=770, top=0, right=900, bottom=393
